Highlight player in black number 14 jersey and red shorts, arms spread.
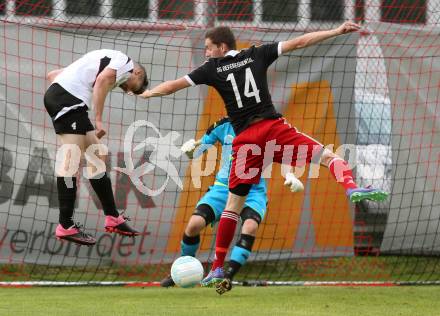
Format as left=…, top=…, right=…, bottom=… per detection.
left=140, top=21, right=388, bottom=294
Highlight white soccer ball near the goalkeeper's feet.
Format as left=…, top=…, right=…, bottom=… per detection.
left=171, top=256, right=203, bottom=288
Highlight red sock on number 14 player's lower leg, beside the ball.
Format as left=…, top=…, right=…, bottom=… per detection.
left=212, top=210, right=238, bottom=270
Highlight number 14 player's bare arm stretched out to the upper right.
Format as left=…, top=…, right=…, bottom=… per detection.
left=281, top=21, right=361, bottom=54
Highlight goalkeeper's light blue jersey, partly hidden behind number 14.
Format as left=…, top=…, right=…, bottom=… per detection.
left=194, top=117, right=267, bottom=192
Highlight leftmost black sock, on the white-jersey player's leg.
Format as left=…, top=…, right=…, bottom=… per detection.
left=57, top=177, right=76, bottom=229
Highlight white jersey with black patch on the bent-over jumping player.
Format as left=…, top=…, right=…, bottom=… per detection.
left=54, top=49, right=134, bottom=106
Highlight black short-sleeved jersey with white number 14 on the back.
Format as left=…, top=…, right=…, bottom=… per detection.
left=185, top=43, right=281, bottom=135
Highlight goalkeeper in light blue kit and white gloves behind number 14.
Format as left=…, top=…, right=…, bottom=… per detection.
left=161, top=117, right=304, bottom=287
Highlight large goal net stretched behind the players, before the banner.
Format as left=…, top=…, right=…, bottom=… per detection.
left=0, top=0, right=440, bottom=283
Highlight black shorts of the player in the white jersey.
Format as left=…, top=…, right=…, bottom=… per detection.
left=44, top=83, right=95, bottom=135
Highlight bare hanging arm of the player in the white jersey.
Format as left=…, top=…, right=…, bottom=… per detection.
left=92, top=68, right=116, bottom=138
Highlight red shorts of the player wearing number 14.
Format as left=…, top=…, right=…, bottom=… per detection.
left=229, top=118, right=324, bottom=189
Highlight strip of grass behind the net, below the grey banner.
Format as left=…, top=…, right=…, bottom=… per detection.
left=0, top=256, right=440, bottom=282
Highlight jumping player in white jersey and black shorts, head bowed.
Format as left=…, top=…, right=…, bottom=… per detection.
left=44, top=49, right=148, bottom=246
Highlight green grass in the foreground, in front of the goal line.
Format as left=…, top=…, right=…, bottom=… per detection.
left=0, top=286, right=440, bottom=316
